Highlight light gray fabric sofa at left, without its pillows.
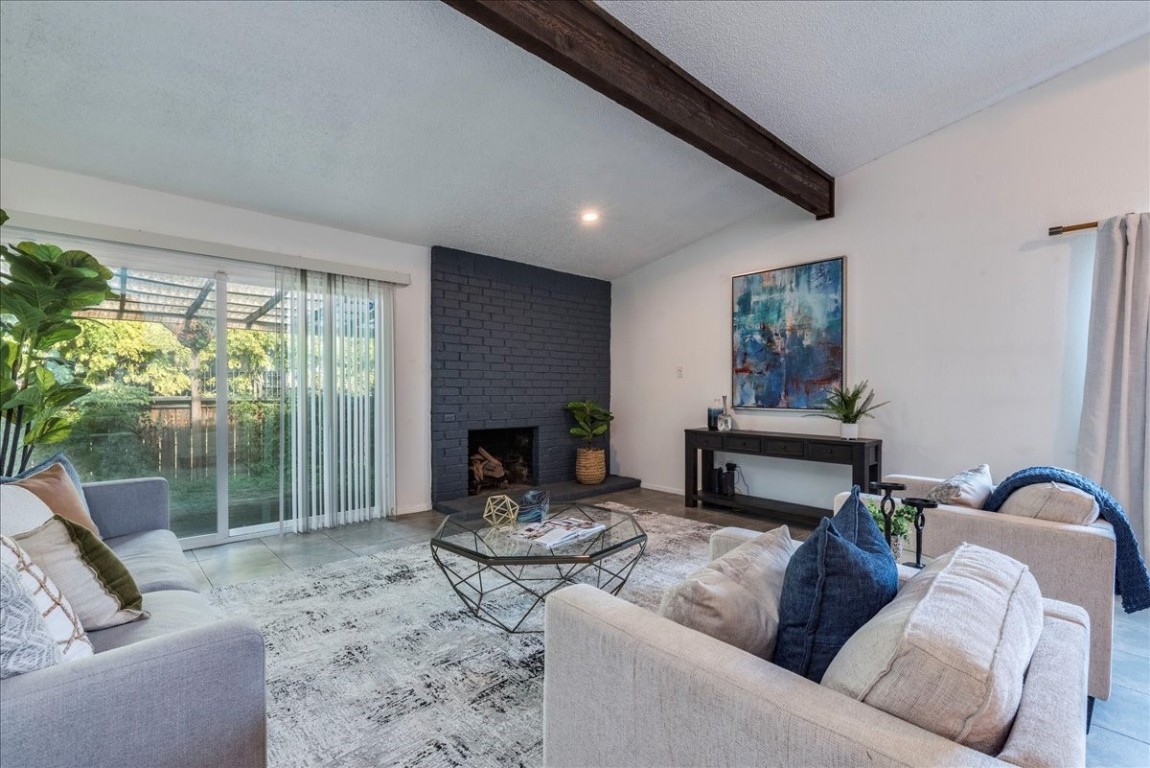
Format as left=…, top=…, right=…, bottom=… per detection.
left=0, top=478, right=267, bottom=768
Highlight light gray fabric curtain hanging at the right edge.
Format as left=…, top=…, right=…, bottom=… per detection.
left=1079, top=214, right=1150, bottom=552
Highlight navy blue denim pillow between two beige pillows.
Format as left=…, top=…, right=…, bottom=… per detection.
left=774, top=485, right=898, bottom=683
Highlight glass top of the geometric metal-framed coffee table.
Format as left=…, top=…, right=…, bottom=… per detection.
left=431, top=504, right=646, bottom=563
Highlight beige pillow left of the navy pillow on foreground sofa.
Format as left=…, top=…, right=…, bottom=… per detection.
left=659, top=525, right=796, bottom=659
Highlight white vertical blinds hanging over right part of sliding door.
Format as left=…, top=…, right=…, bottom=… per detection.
left=284, top=271, right=396, bottom=531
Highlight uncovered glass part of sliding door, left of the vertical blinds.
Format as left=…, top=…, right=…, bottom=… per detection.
left=50, top=255, right=290, bottom=539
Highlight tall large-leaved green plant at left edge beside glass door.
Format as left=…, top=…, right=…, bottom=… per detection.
left=0, top=210, right=116, bottom=475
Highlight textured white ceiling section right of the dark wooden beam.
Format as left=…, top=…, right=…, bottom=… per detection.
left=598, top=0, right=1150, bottom=176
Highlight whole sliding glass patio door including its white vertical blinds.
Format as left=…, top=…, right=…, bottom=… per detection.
left=11, top=227, right=394, bottom=546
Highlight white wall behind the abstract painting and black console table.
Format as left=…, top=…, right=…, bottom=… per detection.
left=612, top=38, right=1150, bottom=505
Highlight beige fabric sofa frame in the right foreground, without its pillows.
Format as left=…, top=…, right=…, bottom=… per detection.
left=543, top=529, right=1090, bottom=768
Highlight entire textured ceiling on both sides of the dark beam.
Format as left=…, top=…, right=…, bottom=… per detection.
left=0, top=0, right=1150, bottom=278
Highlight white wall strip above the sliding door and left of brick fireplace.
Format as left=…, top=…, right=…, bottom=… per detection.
left=0, top=160, right=431, bottom=513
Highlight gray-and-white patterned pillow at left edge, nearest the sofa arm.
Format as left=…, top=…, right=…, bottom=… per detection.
left=0, top=563, right=63, bottom=679
